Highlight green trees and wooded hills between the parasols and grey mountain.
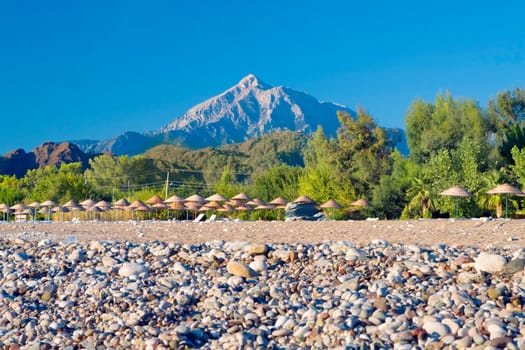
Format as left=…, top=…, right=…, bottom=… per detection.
left=0, top=88, right=525, bottom=219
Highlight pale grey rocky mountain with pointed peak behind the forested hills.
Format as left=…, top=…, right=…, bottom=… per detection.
left=73, top=74, right=404, bottom=155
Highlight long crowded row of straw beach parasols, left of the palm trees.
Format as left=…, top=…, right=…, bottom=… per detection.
left=0, top=193, right=369, bottom=220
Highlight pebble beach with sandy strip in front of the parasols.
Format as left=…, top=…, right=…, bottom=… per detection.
left=0, top=219, right=525, bottom=349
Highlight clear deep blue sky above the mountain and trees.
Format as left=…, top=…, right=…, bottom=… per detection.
left=0, top=0, right=525, bottom=154
